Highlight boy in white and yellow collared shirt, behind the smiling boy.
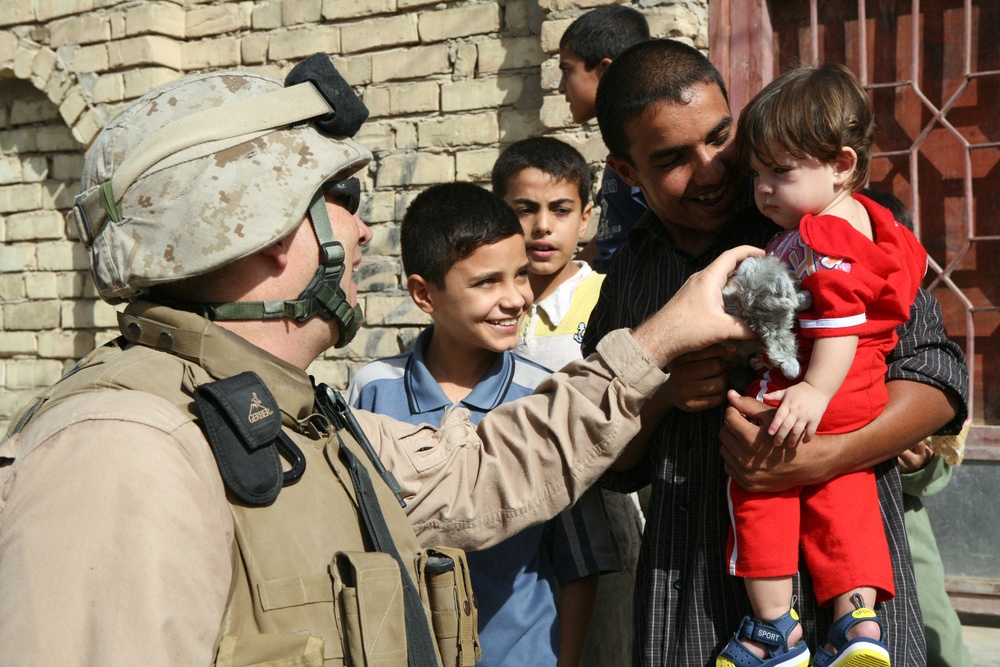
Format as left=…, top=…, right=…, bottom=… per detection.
left=492, top=137, right=642, bottom=666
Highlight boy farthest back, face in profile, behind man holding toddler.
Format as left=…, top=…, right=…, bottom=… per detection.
left=559, top=5, right=649, bottom=273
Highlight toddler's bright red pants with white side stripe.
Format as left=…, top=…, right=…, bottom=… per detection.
left=726, top=470, right=895, bottom=605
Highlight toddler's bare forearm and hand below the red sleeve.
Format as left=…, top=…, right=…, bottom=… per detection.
left=763, top=336, right=858, bottom=447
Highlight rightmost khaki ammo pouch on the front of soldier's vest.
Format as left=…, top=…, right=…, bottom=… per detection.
left=417, top=547, right=483, bottom=667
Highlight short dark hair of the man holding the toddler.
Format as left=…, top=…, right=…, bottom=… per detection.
left=595, top=39, right=729, bottom=163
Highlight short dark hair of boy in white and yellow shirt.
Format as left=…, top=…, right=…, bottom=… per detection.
left=491, top=137, right=593, bottom=208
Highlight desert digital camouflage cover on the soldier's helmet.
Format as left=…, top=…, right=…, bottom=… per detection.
left=78, top=71, right=372, bottom=303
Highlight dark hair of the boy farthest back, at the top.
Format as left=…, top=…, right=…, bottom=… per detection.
left=559, top=5, right=649, bottom=70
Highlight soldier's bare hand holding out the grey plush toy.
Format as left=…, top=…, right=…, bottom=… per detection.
left=632, top=246, right=764, bottom=368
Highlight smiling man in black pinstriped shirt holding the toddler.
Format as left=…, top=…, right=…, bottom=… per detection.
left=583, top=40, right=967, bottom=667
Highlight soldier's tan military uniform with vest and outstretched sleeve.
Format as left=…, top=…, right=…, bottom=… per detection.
left=0, top=303, right=664, bottom=665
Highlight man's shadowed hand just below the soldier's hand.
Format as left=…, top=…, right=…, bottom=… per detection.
left=661, top=344, right=735, bottom=412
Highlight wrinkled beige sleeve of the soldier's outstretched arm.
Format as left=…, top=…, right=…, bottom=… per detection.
left=357, top=330, right=666, bottom=550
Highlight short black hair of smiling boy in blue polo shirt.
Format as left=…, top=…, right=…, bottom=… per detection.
left=400, top=183, right=524, bottom=289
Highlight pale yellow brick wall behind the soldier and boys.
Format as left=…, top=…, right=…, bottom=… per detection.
left=0, top=0, right=708, bottom=428
